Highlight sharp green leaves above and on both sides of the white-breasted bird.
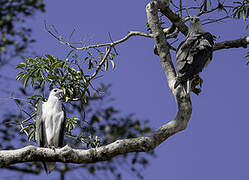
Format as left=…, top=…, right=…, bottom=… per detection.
left=16, top=48, right=115, bottom=147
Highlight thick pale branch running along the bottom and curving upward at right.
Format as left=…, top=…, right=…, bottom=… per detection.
left=0, top=1, right=192, bottom=167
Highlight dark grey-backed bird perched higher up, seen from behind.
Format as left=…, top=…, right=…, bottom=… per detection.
left=174, top=16, right=214, bottom=95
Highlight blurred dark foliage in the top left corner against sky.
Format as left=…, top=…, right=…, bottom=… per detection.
left=0, top=0, right=45, bottom=65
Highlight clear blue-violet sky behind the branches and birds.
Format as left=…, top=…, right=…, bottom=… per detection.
left=0, top=0, right=249, bottom=180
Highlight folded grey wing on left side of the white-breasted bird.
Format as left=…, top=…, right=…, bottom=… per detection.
left=35, top=101, right=45, bottom=147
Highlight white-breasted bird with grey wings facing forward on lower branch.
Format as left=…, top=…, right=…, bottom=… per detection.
left=36, top=88, right=66, bottom=173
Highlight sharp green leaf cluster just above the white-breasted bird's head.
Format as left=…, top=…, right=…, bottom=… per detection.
left=16, top=48, right=115, bottom=103
